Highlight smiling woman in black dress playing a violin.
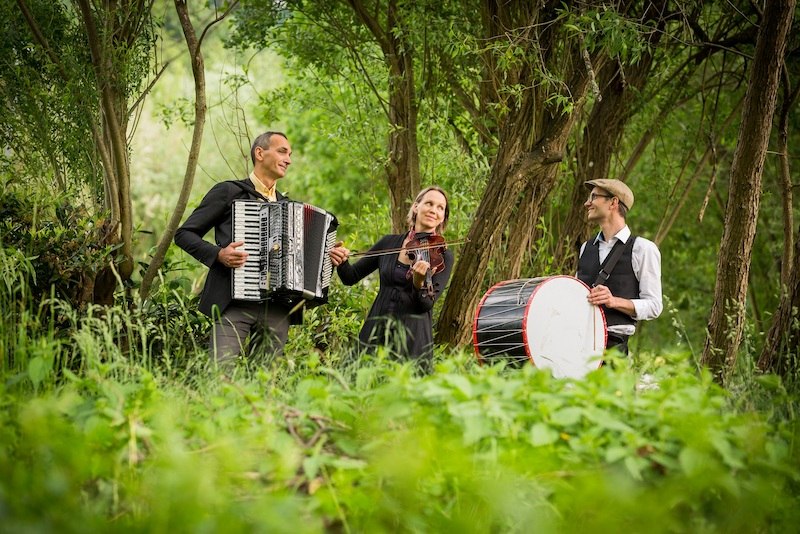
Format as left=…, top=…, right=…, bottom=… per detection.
left=330, top=186, right=453, bottom=360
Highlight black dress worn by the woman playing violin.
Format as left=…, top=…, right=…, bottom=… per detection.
left=337, top=233, right=453, bottom=359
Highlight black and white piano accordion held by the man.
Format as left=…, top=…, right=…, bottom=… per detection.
left=231, top=200, right=339, bottom=306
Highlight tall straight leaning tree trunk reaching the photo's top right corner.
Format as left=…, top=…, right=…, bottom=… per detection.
left=702, top=0, right=795, bottom=383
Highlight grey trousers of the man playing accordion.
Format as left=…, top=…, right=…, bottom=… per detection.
left=209, top=300, right=290, bottom=364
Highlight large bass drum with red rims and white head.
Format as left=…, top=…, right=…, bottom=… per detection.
left=472, top=276, right=606, bottom=378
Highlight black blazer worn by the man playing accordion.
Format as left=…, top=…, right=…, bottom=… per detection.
left=175, top=178, right=300, bottom=324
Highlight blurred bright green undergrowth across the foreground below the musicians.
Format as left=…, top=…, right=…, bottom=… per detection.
left=0, top=352, right=800, bottom=532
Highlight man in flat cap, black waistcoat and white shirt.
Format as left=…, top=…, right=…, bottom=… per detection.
left=578, top=179, right=663, bottom=355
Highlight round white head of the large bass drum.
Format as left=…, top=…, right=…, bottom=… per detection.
left=523, top=276, right=606, bottom=378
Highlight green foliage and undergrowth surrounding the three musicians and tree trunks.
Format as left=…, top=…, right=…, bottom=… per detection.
left=0, top=0, right=800, bottom=532
